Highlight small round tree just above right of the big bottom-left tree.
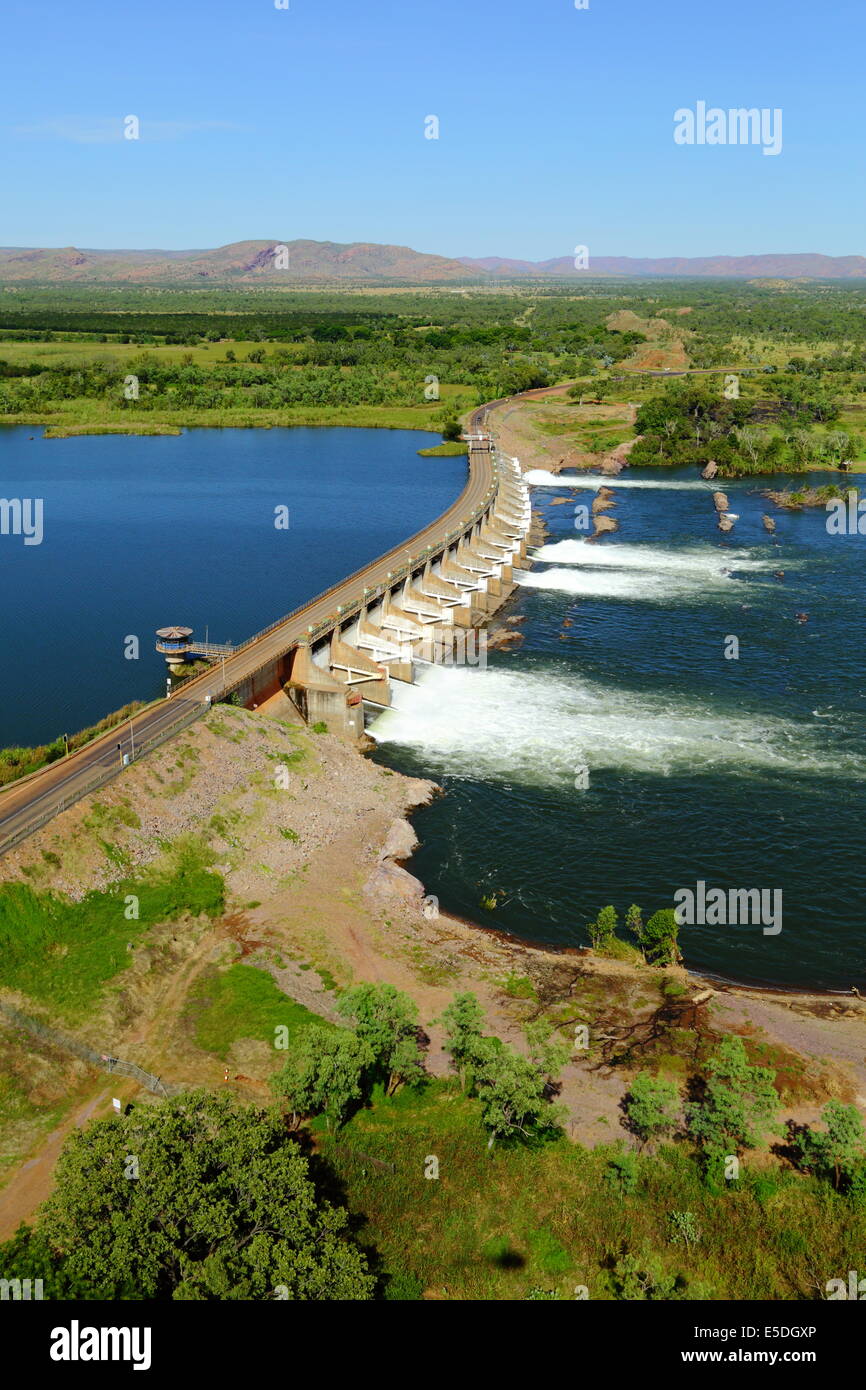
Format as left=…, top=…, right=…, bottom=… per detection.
left=271, top=1024, right=375, bottom=1129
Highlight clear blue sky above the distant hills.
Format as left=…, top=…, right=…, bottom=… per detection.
left=0, top=0, right=866, bottom=260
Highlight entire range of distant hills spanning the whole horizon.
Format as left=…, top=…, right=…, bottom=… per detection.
left=0, top=240, right=866, bottom=286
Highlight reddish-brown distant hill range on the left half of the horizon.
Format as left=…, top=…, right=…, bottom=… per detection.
left=0, top=240, right=477, bottom=285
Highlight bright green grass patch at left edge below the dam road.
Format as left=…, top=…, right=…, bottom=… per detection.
left=0, top=847, right=224, bottom=1020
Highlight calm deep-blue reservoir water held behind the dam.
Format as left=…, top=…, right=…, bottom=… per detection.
left=0, top=427, right=466, bottom=746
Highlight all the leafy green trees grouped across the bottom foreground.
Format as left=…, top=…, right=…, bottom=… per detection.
left=0, top=984, right=866, bottom=1301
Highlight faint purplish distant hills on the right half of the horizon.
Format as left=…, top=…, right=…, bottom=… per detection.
left=460, top=252, right=866, bottom=279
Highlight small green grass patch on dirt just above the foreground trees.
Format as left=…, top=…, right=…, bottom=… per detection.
left=185, top=965, right=332, bottom=1072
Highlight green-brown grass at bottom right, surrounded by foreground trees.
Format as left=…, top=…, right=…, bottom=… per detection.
left=314, top=1081, right=866, bottom=1300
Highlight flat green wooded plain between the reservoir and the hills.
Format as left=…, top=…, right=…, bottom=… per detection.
left=0, top=279, right=866, bottom=475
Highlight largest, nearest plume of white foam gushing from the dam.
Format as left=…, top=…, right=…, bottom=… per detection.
left=368, top=666, right=866, bottom=788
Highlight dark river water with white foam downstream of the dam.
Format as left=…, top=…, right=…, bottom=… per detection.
left=377, top=470, right=866, bottom=990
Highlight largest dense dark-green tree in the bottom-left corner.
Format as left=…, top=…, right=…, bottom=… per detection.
left=22, top=1091, right=374, bottom=1301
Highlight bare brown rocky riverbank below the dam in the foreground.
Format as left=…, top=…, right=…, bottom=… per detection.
left=0, top=695, right=866, bottom=1237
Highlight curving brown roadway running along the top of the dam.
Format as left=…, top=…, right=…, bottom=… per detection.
left=0, top=402, right=514, bottom=853
